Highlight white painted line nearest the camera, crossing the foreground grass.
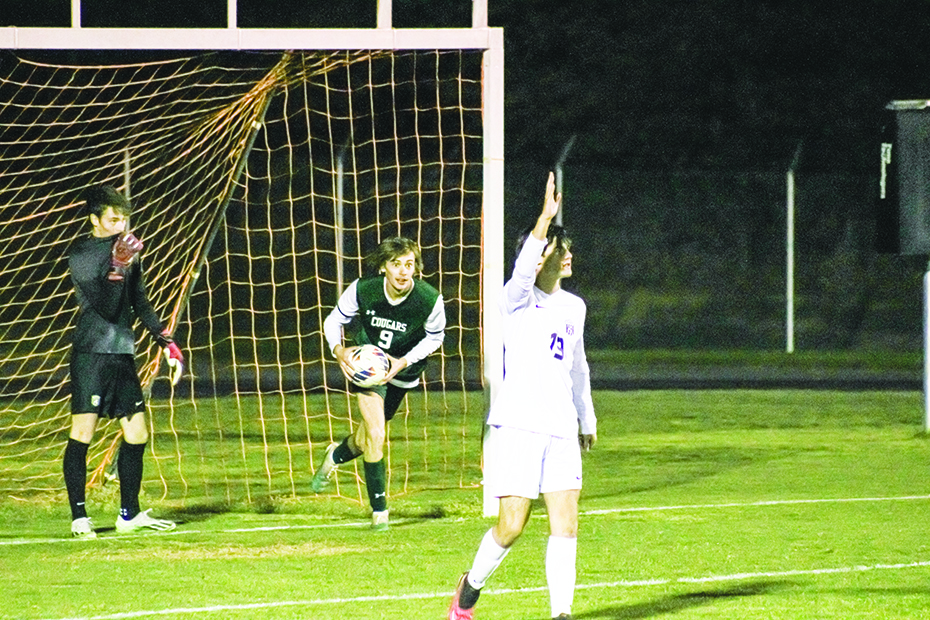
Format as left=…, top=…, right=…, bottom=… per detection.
left=46, top=561, right=930, bottom=620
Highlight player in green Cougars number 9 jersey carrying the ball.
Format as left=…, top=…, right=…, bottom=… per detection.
left=311, top=237, right=446, bottom=530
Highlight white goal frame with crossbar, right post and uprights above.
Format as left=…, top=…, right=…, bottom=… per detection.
left=0, top=0, right=504, bottom=514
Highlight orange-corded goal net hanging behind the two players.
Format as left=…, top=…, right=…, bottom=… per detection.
left=0, top=51, right=484, bottom=504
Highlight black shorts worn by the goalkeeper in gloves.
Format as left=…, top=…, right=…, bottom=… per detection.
left=70, top=351, right=145, bottom=418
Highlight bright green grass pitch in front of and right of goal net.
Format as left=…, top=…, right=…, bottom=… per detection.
left=0, top=390, right=930, bottom=620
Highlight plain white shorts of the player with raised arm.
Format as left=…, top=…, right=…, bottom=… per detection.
left=484, top=426, right=581, bottom=499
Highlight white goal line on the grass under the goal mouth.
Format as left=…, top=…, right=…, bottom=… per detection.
left=7, top=495, right=930, bottom=547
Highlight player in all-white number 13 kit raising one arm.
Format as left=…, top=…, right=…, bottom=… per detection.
left=448, top=174, right=597, bottom=620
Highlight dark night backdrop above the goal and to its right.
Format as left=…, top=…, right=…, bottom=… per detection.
left=0, top=0, right=930, bottom=349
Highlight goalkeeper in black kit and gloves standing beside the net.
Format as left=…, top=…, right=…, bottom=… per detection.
left=64, top=186, right=184, bottom=538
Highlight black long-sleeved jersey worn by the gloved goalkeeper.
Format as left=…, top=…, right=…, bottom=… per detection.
left=68, top=235, right=162, bottom=354
